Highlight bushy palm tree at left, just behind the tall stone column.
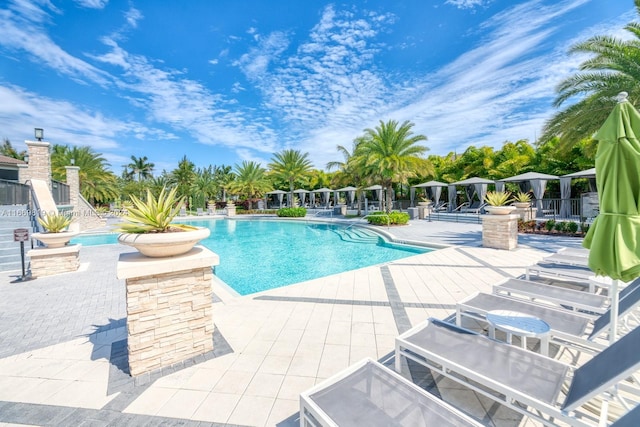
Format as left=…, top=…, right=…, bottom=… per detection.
left=51, top=144, right=119, bottom=204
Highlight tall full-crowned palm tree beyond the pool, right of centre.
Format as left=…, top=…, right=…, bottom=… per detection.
left=358, top=120, right=430, bottom=213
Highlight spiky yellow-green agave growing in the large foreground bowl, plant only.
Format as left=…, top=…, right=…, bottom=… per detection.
left=119, top=187, right=196, bottom=234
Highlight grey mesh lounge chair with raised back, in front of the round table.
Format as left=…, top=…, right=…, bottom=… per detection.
left=395, top=319, right=640, bottom=427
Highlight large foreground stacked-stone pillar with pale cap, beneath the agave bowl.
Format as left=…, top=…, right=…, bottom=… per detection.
left=117, top=246, right=220, bottom=377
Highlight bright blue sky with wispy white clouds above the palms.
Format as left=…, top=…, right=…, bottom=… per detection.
left=0, top=0, right=636, bottom=174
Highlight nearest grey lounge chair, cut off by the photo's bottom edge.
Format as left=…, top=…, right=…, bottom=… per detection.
left=300, top=359, right=482, bottom=427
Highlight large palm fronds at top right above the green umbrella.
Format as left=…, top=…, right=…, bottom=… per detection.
left=541, top=0, right=640, bottom=148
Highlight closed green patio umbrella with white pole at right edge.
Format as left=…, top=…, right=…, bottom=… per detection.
left=583, top=92, right=640, bottom=341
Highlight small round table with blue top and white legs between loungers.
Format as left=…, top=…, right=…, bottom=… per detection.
left=486, top=310, right=551, bottom=356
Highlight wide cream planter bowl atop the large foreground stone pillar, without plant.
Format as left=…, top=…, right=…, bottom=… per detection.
left=118, top=227, right=211, bottom=258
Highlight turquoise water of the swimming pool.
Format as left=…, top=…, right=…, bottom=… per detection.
left=71, top=219, right=430, bottom=295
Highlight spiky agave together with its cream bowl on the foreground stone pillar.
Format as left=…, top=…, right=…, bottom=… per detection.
left=118, top=188, right=210, bottom=258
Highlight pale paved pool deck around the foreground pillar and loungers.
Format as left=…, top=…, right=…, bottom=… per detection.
left=0, top=220, right=581, bottom=426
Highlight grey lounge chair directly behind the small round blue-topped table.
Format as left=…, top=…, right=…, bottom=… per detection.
left=456, top=280, right=640, bottom=350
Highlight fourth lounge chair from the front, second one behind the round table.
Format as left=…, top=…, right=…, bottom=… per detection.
left=493, top=278, right=640, bottom=314
